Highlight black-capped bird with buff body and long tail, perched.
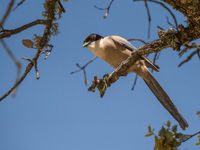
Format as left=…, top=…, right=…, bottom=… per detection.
left=82, top=33, right=188, bottom=130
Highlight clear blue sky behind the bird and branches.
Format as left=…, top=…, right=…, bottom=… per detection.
left=0, top=0, right=200, bottom=150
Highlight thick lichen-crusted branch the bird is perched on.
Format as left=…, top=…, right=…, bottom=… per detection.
left=88, top=26, right=200, bottom=97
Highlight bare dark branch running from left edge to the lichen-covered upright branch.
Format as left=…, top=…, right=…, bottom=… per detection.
left=0, top=19, right=47, bottom=39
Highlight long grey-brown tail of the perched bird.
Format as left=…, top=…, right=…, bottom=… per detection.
left=144, top=72, right=188, bottom=130
